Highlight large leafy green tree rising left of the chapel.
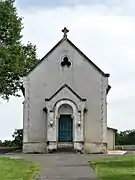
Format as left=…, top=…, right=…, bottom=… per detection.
left=0, top=0, right=38, bottom=99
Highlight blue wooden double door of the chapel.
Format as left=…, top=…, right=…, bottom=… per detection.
left=59, top=115, right=73, bottom=142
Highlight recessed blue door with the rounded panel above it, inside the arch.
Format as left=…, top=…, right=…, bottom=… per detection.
left=58, top=104, right=73, bottom=143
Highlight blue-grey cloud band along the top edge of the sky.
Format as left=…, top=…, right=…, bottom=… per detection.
left=16, top=0, right=135, bottom=15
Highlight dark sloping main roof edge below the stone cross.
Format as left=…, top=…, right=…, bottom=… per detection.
left=27, top=37, right=110, bottom=77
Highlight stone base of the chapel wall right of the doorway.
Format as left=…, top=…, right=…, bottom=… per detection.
left=84, top=142, right=107, bottom=154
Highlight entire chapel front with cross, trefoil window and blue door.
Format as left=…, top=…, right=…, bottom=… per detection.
left=23, top=28, right=115, bottom=153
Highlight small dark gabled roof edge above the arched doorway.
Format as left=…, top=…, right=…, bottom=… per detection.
left=45, top=84, right=86, bottom=101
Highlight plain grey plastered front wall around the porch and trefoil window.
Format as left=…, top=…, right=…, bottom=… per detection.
left=22, top=38, right=107, bottom=153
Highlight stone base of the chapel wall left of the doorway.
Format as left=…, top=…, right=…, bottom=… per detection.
left=23, top=142, right=46, bottom=154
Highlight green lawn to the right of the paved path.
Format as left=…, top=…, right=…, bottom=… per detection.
left=91, top=156, right=135, bottom=180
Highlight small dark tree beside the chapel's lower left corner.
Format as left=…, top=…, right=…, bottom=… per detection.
left=12, top=129, right=23, bottom=149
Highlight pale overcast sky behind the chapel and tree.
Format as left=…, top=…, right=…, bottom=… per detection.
left=0, top=0, right=135, bottom=140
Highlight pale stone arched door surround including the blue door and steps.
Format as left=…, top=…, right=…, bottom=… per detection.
left=47, top=99, right=85, bottom=152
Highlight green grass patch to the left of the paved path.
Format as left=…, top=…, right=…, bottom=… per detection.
left=0, top=158, right=39, bottom=180
